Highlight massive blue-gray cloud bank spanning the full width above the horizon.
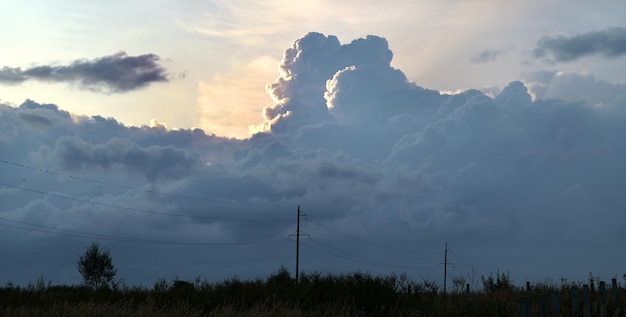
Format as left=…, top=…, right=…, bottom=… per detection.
left=0, top=33, right=626, bottom=285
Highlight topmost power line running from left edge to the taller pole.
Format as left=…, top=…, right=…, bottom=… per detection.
left=0, top=160, right=293, bottom=208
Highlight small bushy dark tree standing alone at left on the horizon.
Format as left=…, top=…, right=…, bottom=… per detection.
left=78, top=242, right=117, bottom=288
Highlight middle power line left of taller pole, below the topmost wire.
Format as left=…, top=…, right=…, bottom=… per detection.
left=0, top=182, right=291, bottom=222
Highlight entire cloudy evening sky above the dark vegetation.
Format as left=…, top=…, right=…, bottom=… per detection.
left=0, top=0, right=626, bottom=286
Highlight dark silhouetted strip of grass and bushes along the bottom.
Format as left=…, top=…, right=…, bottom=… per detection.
left=0, top=268, right=626, bottom=317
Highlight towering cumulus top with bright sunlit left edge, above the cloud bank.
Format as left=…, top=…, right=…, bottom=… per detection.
left=252, top=32, right=393, bottom=133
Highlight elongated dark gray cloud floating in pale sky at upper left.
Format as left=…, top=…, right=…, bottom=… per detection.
left=0, top=52, right=168, bottom=93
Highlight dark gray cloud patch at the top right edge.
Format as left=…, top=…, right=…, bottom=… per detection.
left=533, top=27, right=626, bottom=62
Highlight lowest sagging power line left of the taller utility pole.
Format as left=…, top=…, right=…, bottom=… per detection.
left=0, top=218, right=286, bottom=246
